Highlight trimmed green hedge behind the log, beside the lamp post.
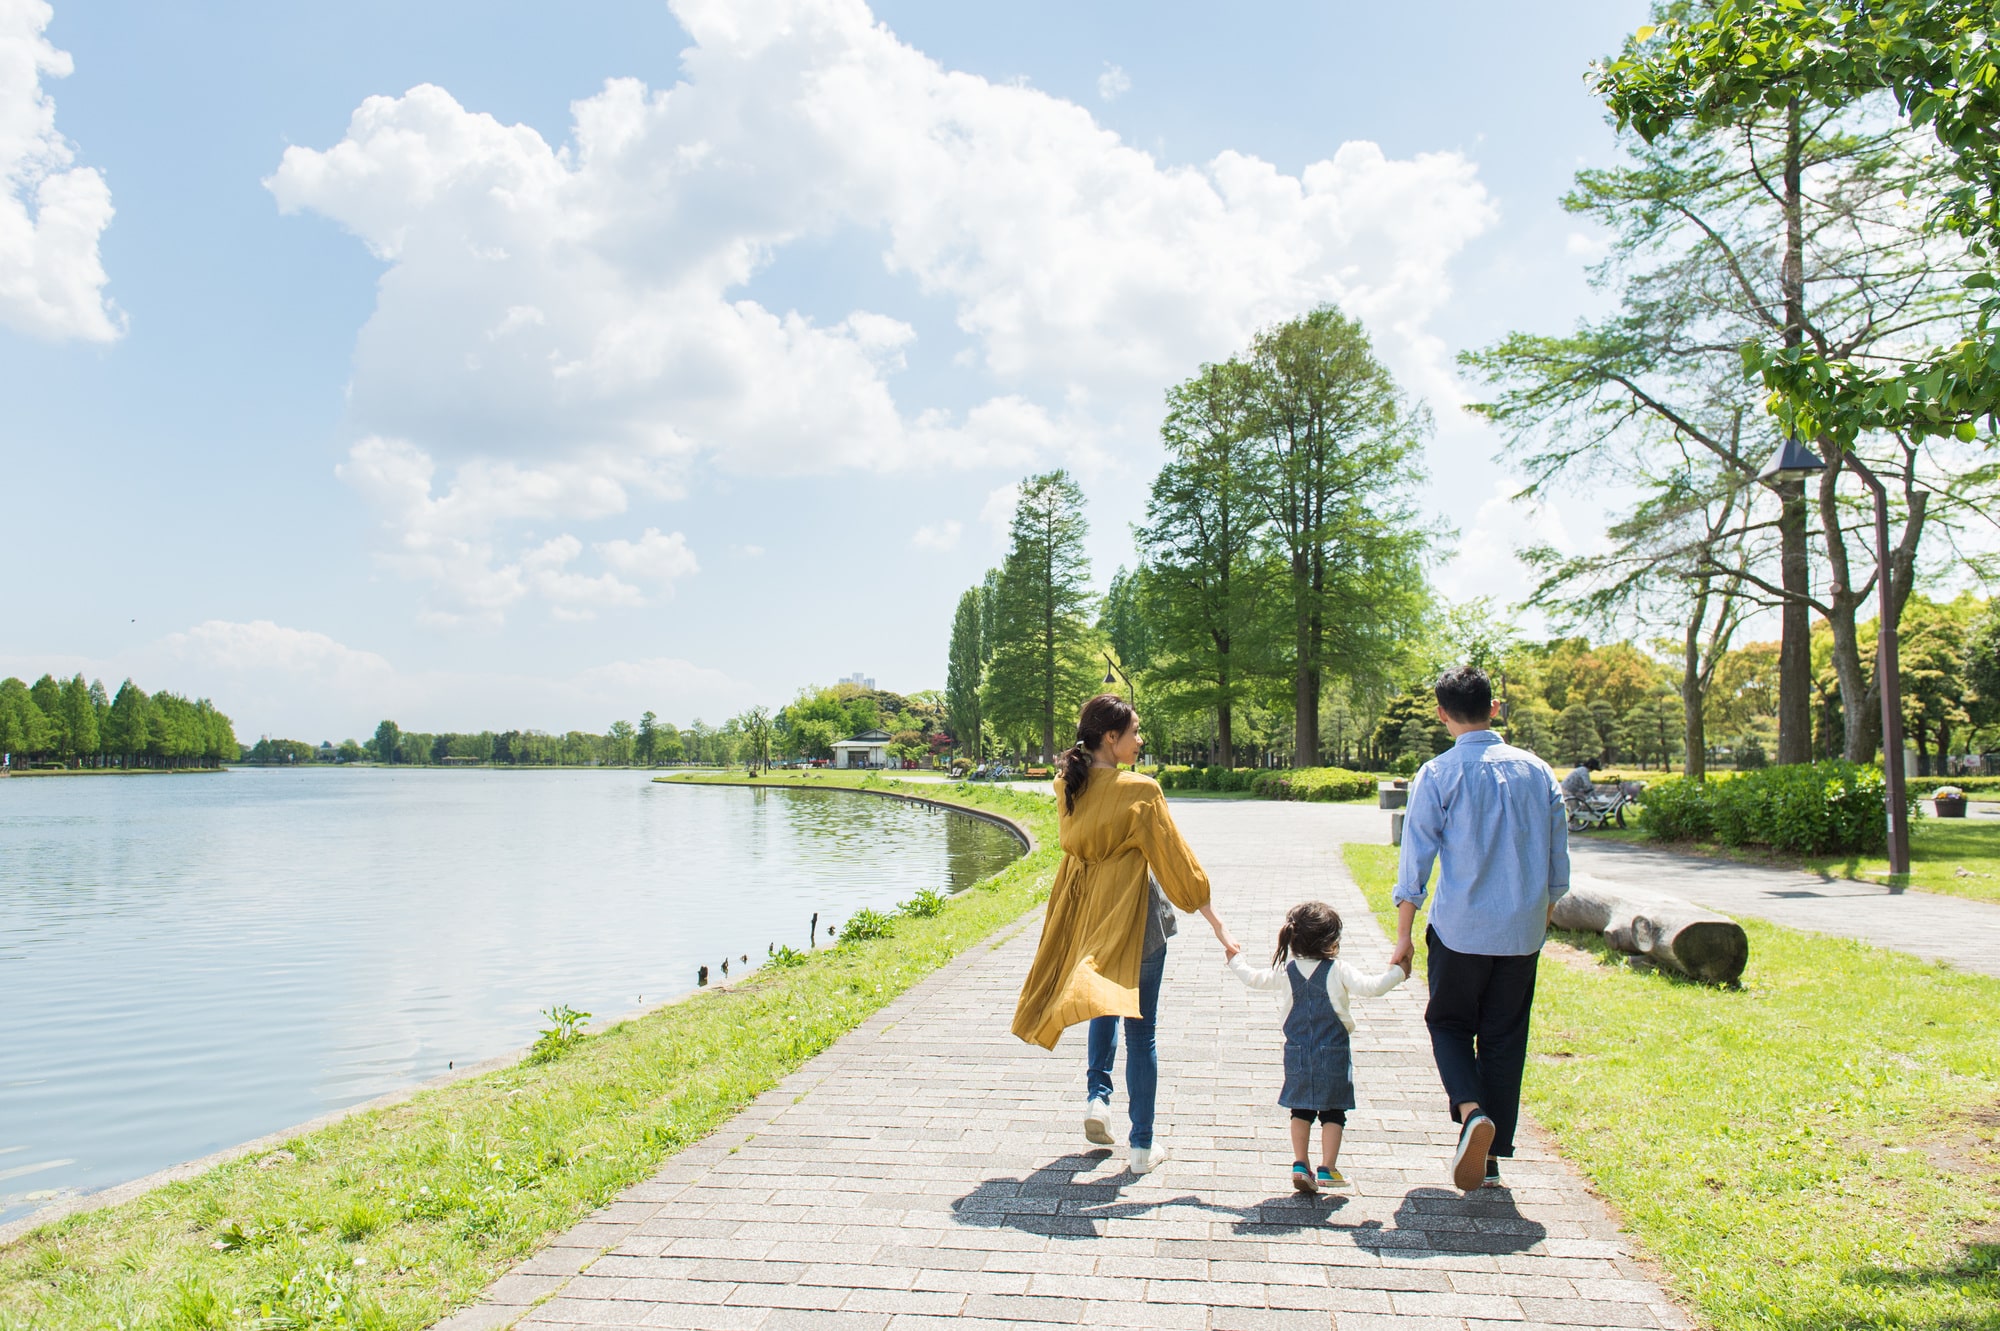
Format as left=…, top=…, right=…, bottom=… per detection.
left=1640, top=759, right=1916, bottom=855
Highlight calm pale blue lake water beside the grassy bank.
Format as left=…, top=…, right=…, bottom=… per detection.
left=0, top=769, right=1020, bottom=1221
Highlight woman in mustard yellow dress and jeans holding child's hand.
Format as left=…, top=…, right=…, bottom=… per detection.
left=1014, top=693, right=1238, bottom=1173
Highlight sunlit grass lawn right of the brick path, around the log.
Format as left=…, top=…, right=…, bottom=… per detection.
left=1342, top=845, right=2000, bottom=1331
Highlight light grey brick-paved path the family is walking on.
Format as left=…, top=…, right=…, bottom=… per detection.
left=444, top=803, right=1688, bottom=1331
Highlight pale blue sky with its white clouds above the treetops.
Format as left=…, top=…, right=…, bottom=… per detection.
left=0, top=0, right=1644, bottom=739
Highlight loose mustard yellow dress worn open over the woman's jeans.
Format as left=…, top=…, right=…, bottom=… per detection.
left=1014, top=767, right=1208, bottom=1049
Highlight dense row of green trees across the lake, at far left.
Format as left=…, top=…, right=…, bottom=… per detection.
left=0, top=675, right=242, bottom=767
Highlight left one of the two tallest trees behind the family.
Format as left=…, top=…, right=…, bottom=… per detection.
left=1136, top=362, right=1272, bottom=767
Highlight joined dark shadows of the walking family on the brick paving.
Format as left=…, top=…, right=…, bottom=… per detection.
left=952, top=1151, right=1548, bottom=1257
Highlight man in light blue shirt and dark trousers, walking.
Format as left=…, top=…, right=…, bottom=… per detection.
left=1390, top=666, right=1570, bottom=1191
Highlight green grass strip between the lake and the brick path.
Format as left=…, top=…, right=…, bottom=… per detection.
left=0, top=773, right=1060, bottom=1331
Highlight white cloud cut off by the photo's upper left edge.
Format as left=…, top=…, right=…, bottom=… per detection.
left=0, top=0, right=126, bottom=342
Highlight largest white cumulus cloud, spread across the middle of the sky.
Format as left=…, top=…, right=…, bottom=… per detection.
left=266, top=0, right=1494, bottom=618
